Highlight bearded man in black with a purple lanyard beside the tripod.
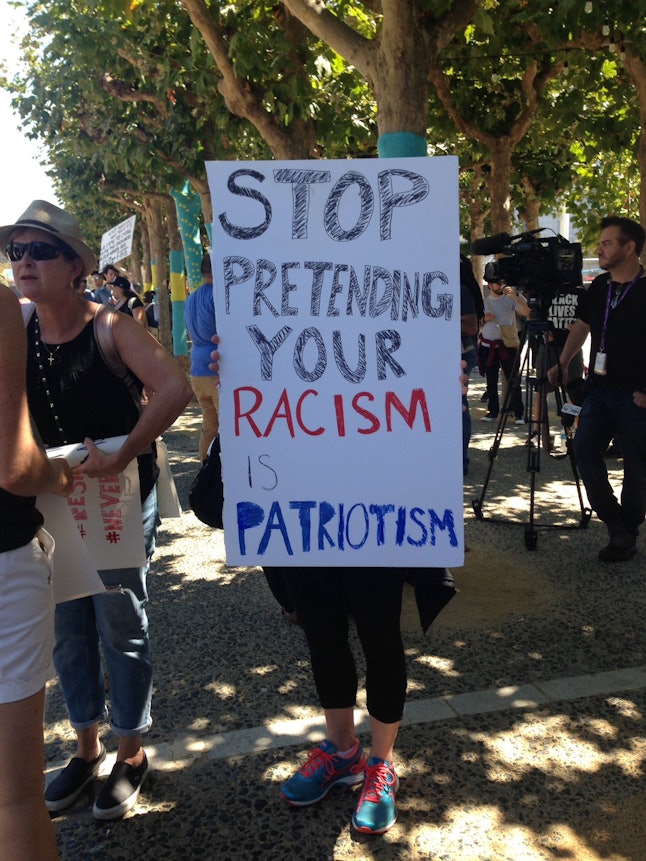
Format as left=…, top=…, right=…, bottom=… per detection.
left=548, top=216, right=646, bottom=562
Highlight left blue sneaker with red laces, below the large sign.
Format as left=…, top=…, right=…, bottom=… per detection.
left=280, top=739, right=366, bottom=807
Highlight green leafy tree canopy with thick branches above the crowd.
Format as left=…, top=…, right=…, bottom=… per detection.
left=4, top=0, right=646, bottom=256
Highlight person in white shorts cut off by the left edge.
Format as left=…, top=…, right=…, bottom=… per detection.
left=0, top=285, right=72, bottom=861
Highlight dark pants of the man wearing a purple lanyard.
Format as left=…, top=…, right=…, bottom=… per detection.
left=574, top=389, right=646, bottom=533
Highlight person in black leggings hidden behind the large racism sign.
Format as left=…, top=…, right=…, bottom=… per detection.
left=209, top=335, right=460, bottom=834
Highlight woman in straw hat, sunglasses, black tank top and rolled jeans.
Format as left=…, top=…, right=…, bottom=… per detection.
left=0, top=200, right=191, bottom=819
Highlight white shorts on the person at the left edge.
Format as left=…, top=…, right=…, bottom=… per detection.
left=0, top=529, right=54, bottom=703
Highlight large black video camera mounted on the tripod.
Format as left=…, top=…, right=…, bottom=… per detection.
left=471, top=227, right=583, bottom=314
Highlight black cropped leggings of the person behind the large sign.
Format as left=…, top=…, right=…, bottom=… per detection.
left=269, top=568, right=406, bottom=723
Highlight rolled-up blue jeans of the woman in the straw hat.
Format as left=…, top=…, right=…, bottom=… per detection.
left=54, top=488, right=159, bottom=737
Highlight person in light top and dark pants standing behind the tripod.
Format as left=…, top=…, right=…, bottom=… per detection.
left=478, top=276, right=530, bottom=425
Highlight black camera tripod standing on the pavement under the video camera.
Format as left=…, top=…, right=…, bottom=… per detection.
left=472, top=320, right=592, bottom=550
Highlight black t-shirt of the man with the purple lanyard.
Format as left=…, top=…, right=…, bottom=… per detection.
left=577, top=272, right=646, bottom=391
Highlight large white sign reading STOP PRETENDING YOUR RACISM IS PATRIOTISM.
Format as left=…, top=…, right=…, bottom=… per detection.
left=207, top=157, right=464, bottom=567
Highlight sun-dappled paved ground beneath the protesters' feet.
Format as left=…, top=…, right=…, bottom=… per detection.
left=46, top=392, right=646, bottom=861
